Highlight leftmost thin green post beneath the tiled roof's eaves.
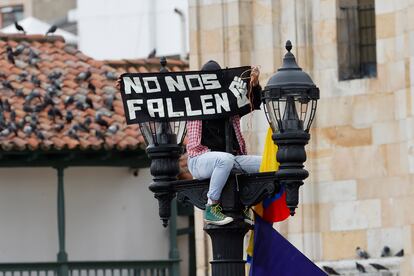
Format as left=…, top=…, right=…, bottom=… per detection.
left=56, top=167, right=69, bottom=276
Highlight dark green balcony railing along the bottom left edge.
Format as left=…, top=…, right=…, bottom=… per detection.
left=0, top=260, right=179, bottom=276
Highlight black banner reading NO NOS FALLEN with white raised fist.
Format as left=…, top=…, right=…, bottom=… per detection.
left=121, top=66, right=251, bottom=124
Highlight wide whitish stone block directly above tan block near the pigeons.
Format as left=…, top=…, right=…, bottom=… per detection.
left=330, top=199, right=381, bottom=231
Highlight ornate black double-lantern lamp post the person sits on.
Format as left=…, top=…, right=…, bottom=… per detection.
left=136, top=41, right=319, bottom=276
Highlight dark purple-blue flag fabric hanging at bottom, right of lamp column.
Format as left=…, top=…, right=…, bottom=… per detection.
left=250, top=215, right=326, bottom=276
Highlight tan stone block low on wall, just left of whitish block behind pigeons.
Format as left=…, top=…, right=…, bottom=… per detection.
left=322, top=230, right=367, bottom=261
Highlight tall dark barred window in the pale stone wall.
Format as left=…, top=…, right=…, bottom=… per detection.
left=337, top=0, right=377, bottom=80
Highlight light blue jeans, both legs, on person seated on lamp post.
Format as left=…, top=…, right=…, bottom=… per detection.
left=188, top=151, right=262, bottom=201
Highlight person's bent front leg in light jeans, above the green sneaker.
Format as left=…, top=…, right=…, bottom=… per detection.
left=188, top=151, right=234, bottom=203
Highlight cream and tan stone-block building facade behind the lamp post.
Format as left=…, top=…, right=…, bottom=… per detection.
left=189, top=0, right=414, bottom=275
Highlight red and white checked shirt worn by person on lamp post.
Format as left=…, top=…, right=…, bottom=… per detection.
left=187, top=115, right=246, bottom=157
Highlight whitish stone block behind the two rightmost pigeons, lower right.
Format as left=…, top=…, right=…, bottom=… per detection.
left=367, top=227, right=405, bottom=258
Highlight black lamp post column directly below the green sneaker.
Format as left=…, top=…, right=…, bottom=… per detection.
left=204, top=221, right=250, bottom=276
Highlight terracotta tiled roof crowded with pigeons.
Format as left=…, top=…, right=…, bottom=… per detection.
left=0, top=34, right=188, bottom=154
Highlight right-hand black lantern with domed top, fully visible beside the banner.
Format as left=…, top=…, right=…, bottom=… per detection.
left=262, top=40, right=319, bottom=216
